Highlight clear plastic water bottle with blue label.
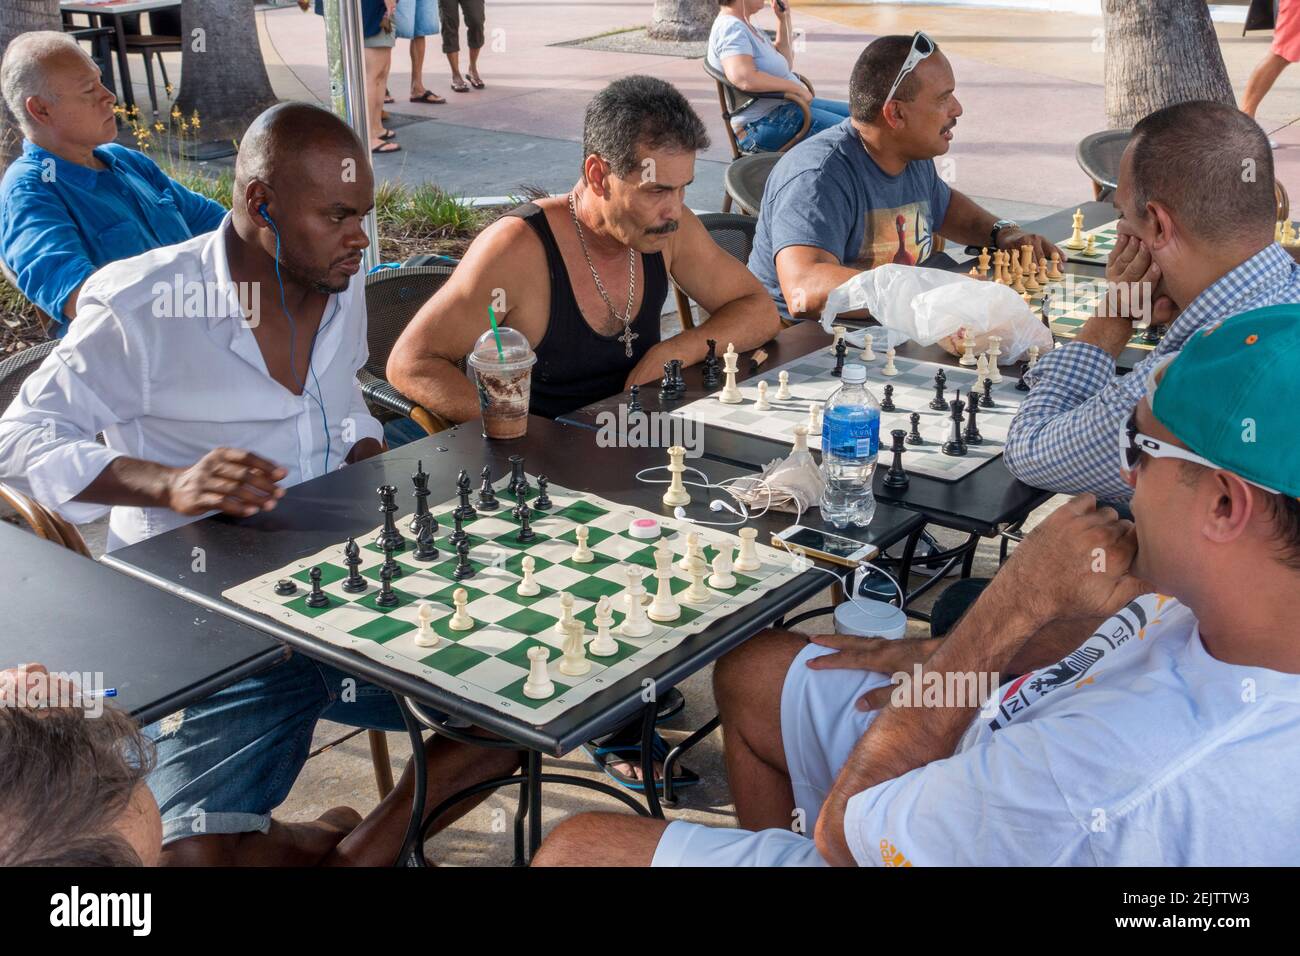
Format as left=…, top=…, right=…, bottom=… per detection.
left=820, top=365, right=880, bottom=528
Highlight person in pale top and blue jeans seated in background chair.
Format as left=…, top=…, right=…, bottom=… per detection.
left=712, top=0, right=849, bottom=152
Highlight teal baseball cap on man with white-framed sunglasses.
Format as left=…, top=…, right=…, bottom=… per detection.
left=1151, top=304, right=1300, bottom=498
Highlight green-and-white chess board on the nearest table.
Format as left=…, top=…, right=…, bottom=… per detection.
left=222, top=477, right=800, bottom=726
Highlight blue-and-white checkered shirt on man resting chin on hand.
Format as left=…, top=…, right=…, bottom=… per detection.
left=1002, top=243, right=1300, bottom=501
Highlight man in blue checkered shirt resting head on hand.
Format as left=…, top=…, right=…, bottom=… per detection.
left=1004, top=101, right=1300, bottom=502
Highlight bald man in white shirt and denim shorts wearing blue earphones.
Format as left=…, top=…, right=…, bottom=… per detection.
left=0, top=103, right=519, bottom=865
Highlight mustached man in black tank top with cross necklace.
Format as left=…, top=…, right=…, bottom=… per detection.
left=387, top=77, right=780, bottom=423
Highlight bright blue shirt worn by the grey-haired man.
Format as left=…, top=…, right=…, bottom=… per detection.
left=0, top=142, right=226, bottom=337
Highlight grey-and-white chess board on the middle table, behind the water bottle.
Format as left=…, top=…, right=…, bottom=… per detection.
left=673, top=349, right=1028, bottom=481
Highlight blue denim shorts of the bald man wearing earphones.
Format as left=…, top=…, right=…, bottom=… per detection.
left=144, top=652, right=406, bottom=844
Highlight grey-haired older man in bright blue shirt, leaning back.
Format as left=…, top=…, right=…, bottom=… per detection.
left=0, top=31, right=225, bottom=337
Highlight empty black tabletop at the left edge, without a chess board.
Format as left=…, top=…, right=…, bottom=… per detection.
left=0, top=523, right=287, bottom=723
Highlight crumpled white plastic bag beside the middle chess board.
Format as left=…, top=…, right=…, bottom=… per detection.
left=822, top=263, right=1052, bottom=365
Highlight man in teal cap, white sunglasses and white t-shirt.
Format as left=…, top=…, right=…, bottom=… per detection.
left=537, top=306, right=1300, bottom=866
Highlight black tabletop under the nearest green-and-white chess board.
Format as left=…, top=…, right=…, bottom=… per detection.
left=105, top=416, right=919, bottom=754
